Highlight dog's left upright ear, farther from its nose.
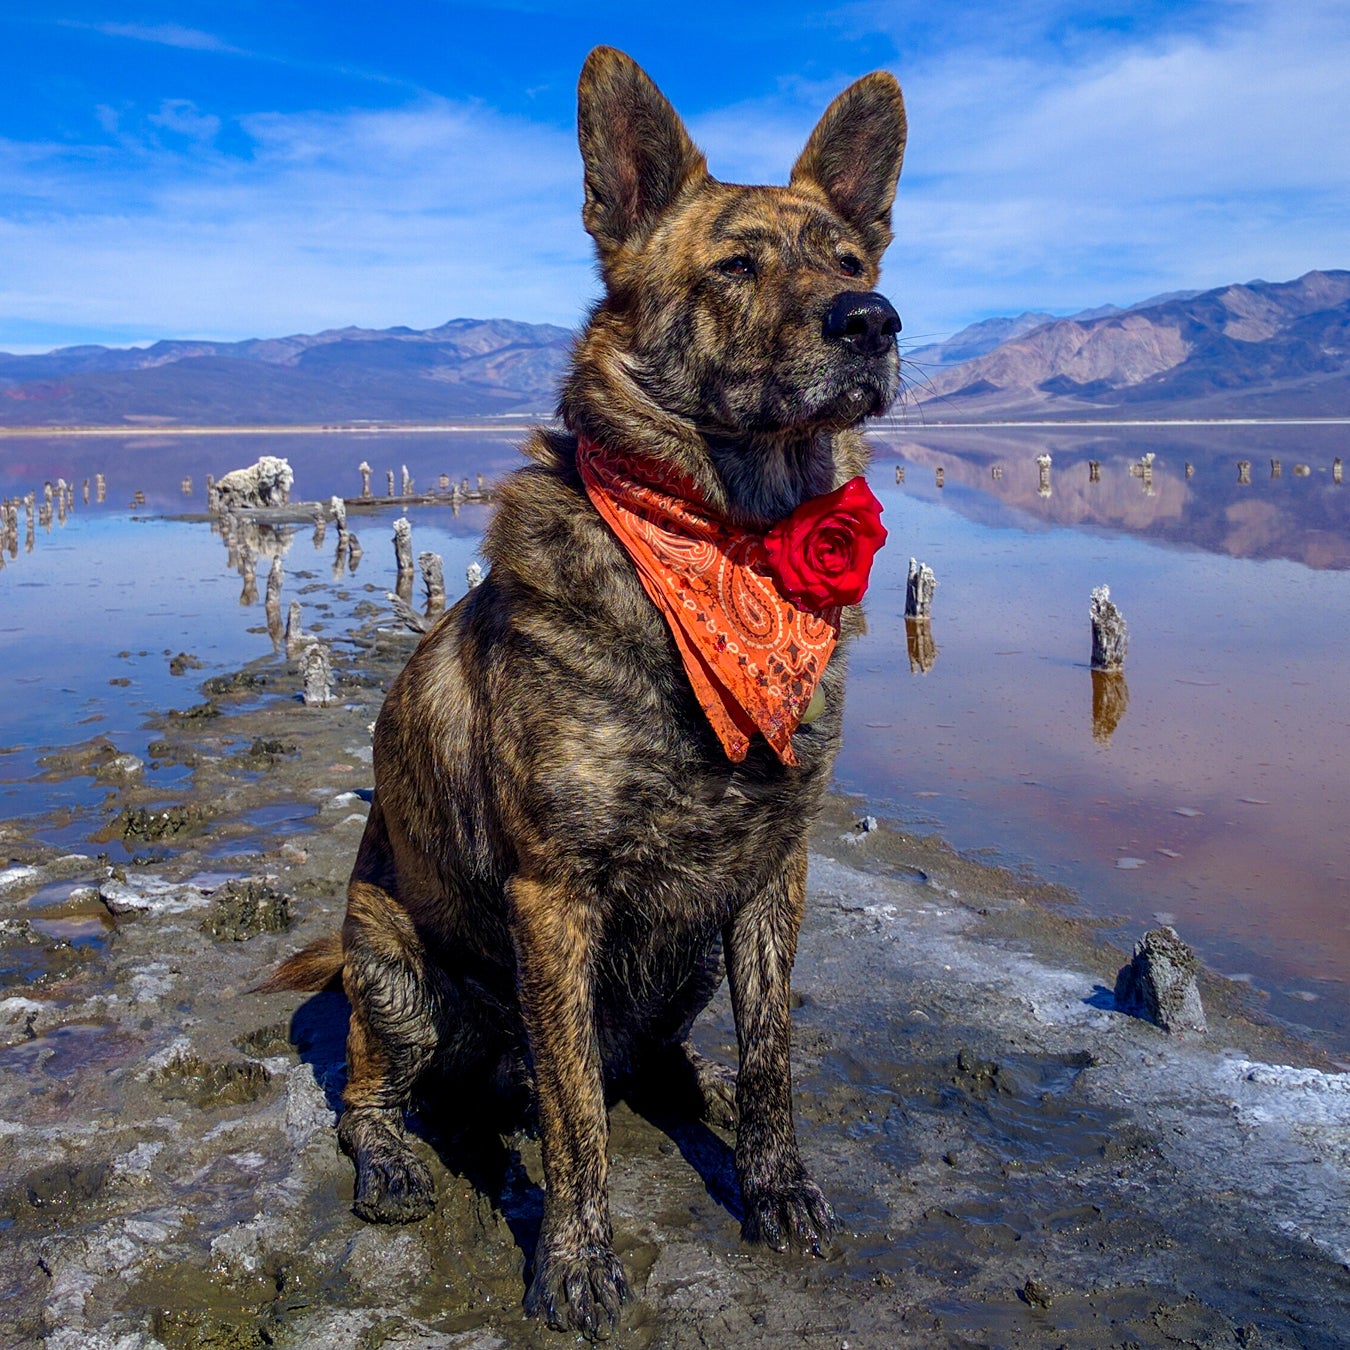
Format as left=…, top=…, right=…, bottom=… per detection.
left=576, top=47, right=707, bottom=258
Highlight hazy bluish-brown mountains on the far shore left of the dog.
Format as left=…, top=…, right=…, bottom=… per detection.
left=0, top=319, right=571, bottom=427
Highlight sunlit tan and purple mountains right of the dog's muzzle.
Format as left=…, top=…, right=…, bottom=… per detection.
left=910, top=271, right=1350, bottom=421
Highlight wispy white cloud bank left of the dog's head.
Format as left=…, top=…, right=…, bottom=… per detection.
left=0, top=100, right=593, bottom=338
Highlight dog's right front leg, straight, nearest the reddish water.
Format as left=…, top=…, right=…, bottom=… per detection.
left=724, top=846, right=834, bottom=1253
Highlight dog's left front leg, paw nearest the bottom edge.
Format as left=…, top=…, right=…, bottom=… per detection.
left=506, top=876, right=628, bottom=1337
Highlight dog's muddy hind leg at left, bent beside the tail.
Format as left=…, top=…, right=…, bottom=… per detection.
left=338, top=880, right=443, bottom=1223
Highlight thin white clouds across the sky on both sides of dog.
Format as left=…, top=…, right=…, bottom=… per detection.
left=0, top=0, right=1350, bottom=346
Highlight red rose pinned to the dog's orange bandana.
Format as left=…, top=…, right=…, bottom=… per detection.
left=764, top=477, right=886, bottom=610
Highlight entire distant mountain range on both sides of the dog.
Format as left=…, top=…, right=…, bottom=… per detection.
left=0, top=271, right=1350, bottom=429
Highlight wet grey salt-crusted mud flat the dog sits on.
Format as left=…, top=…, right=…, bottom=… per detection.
left=0, top=615, right=1350, bottom=1350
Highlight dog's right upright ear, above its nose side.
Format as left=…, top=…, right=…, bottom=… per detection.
left=792, top=70, right=906, bottom=258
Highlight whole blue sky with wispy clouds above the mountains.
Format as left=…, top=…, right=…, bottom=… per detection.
left=0, top=0, right=1350, bottom=351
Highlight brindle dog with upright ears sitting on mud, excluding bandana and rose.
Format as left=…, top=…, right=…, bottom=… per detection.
left=270, top=47, right=905, bottom=1335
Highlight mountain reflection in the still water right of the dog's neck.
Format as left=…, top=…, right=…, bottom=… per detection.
left=875, top=427, right=1350, bottom=570
